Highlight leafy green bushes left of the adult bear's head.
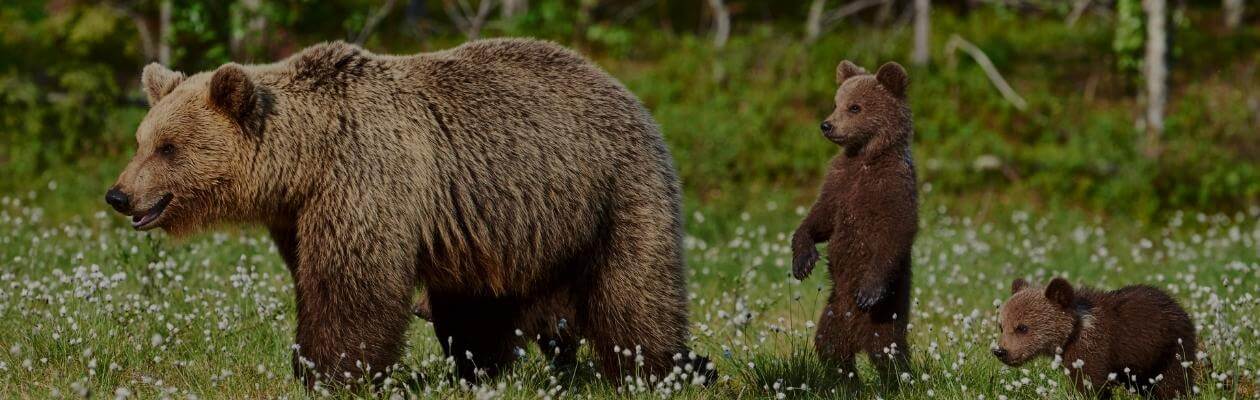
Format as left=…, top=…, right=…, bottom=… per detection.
left=0, top=1, right=147, bottom=175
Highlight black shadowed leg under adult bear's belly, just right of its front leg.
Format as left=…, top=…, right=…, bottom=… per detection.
left=428, top=291, right=522, bottom=382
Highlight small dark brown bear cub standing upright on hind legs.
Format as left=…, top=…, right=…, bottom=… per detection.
left=791, top=61, right=919, bottom=381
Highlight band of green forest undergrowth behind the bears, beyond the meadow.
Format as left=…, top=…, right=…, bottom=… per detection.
left=0, top=0, right=1260, bottom=216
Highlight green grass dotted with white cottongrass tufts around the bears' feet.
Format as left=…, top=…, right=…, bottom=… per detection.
left=0, top=168, right=1260, bottom=399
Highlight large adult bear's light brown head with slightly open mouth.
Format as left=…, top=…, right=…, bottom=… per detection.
left=106, top=63, right=261, bottom=233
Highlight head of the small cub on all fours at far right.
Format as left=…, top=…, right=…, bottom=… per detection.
left=993, top=279, right=1076, bottom=366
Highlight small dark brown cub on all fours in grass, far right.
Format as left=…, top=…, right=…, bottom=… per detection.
left=993, top=278, right=1196, bottom=399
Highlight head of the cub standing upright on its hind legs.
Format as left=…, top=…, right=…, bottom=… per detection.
left=822, top=61, right=910, bottom=151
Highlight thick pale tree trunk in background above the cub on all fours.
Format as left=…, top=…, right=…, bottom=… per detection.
left=1142, top=0, right=1168, bottom=158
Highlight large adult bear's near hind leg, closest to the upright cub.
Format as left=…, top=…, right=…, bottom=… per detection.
left=576, top=204, right=716, bottom=382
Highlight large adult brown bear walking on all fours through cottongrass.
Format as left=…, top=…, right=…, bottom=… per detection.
left=106, top=39, right=712, bottom=385
